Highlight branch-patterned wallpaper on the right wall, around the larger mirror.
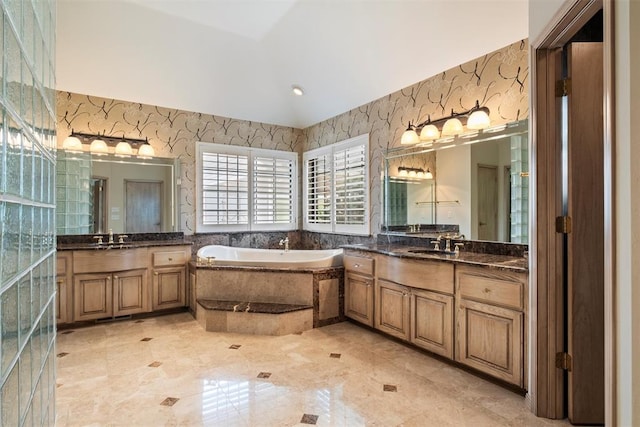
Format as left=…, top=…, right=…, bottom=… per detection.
left=304, top=40, right=529, bottom=234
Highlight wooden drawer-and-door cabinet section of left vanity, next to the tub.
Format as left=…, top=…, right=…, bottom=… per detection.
left=151, top=246, right=191, bottom=311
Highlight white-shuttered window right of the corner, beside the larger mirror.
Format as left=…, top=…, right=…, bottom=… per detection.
left=303, top=134, right=370, bottom=235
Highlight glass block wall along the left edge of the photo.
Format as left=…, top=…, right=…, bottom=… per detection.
left=0, top=0, right=56, bottom=426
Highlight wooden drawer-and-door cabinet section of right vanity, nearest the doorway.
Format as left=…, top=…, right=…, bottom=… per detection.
left=456, top=266, right=527, bottom=388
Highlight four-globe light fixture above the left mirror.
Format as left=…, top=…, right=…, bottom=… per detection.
left=62, top=129, right=155, bottom=159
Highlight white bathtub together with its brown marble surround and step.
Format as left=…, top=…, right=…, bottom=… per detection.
left=189, top=245, right=344, bottom=335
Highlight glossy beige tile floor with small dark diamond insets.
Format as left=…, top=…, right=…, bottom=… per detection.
left=56, top=313, right=566, bottom=426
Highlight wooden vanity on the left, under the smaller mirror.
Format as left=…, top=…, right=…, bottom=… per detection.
left=56, top=239, right=191, bottom=324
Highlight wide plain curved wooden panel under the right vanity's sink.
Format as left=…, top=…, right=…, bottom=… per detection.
left=378, top=257, right=453, bottom=294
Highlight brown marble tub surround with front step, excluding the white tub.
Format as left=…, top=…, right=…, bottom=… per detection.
left=189, top=262, right=344, bottom=335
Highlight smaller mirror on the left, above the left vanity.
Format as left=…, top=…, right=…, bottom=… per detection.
left=56, top=150, right=179, bottom=235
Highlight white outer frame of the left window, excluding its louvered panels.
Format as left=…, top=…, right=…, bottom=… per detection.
left=195, top=141, right=298, bottom=233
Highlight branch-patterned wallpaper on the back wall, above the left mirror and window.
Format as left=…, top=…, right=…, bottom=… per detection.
left=57, top=92, right=304, bottom=234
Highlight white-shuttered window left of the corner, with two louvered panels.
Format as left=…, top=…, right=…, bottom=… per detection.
left=196, top=142, right=298, bottom=232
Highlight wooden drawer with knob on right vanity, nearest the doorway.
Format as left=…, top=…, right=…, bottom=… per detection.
left=456, top=268, right=525, bottom=310
